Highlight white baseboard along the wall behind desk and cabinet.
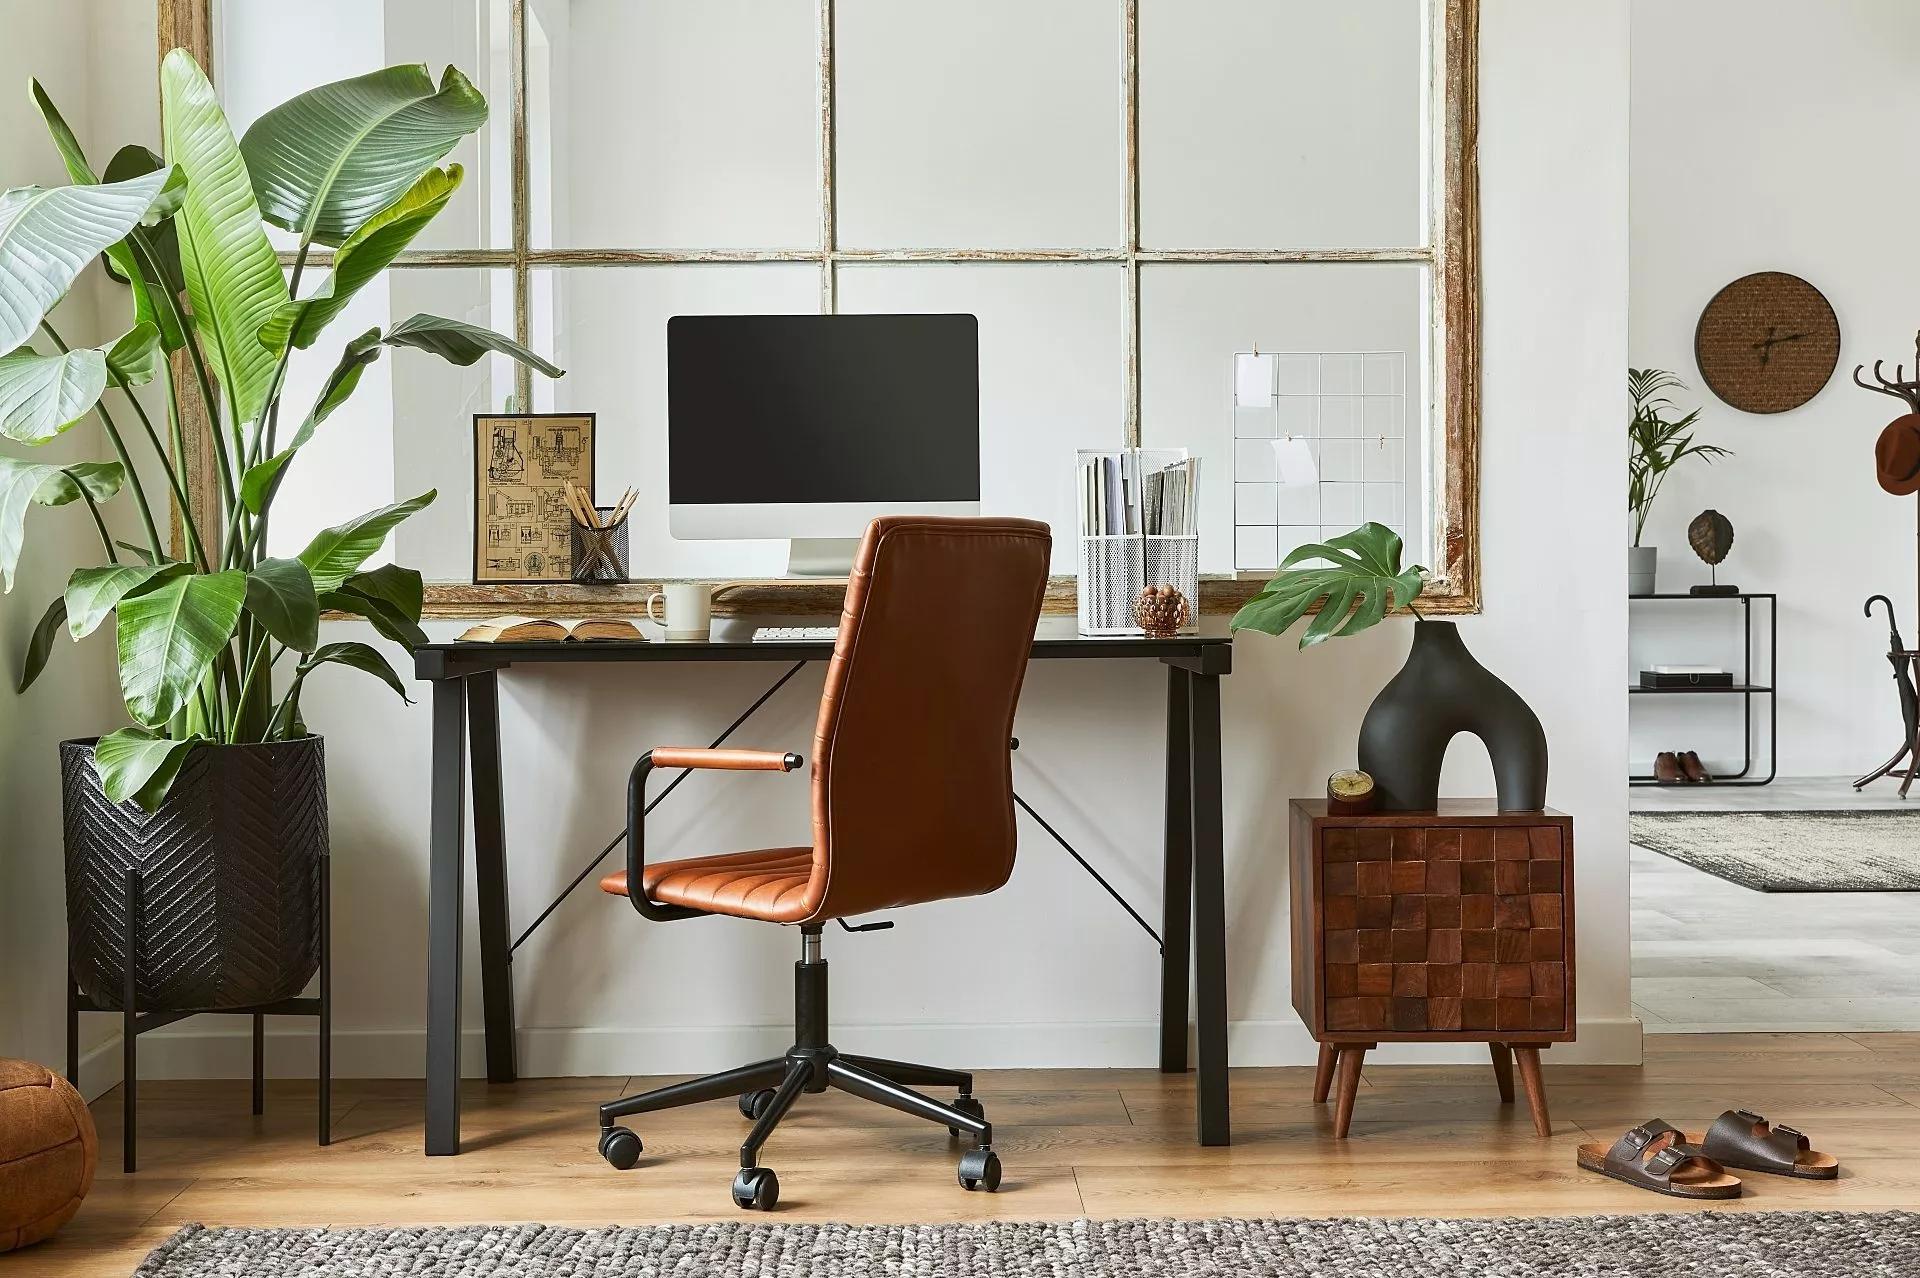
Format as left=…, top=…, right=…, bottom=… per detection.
left=81, top=1017, right=1642, bottom=1098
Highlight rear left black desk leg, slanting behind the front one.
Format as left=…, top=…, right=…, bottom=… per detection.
left=465, top=670, right=515, bottom=1082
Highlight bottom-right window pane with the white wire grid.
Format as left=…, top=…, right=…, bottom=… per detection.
left=1140, top=263, right=1432, bottom=572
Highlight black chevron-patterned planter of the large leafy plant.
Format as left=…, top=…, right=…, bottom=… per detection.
left=60, top=737, right=326, bottom=1011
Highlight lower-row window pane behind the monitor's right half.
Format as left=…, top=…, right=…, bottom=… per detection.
left=839, top=263, right=1127, bottom=574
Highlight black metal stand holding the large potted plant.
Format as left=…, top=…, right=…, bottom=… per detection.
left=67, top=854, right=334, bottom=1172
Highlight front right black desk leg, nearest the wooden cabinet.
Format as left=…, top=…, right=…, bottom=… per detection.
left=1188, top=674, right=1233, bottom=1146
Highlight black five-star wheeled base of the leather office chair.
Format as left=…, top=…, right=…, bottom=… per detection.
left=599, top=923, right=1000, bottom=1211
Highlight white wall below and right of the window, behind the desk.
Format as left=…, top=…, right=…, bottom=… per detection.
left=11, top=0, right=1640, bottom=1075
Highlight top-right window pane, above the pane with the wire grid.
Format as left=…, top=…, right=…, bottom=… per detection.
left=1140, top=0, right=1428, bottom=248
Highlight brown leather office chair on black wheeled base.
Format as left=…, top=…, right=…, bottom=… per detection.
left=599, top=516, right=1052, bottom=1211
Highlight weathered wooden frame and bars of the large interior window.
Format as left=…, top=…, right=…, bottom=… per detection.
left=168, top=0, right=1480, bottom=618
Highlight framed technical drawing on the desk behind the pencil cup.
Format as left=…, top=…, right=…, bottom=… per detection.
left=474, top=413, right=593, bottom=585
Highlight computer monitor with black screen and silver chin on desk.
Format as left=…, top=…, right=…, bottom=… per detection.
left=666, top=315, right=979, bottom=572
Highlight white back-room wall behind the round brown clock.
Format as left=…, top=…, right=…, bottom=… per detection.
left=1609, top=0, right=1920, bottom=777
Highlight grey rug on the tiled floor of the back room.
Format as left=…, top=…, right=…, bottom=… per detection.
left=1628, top=810, right=1920, bottom=892
